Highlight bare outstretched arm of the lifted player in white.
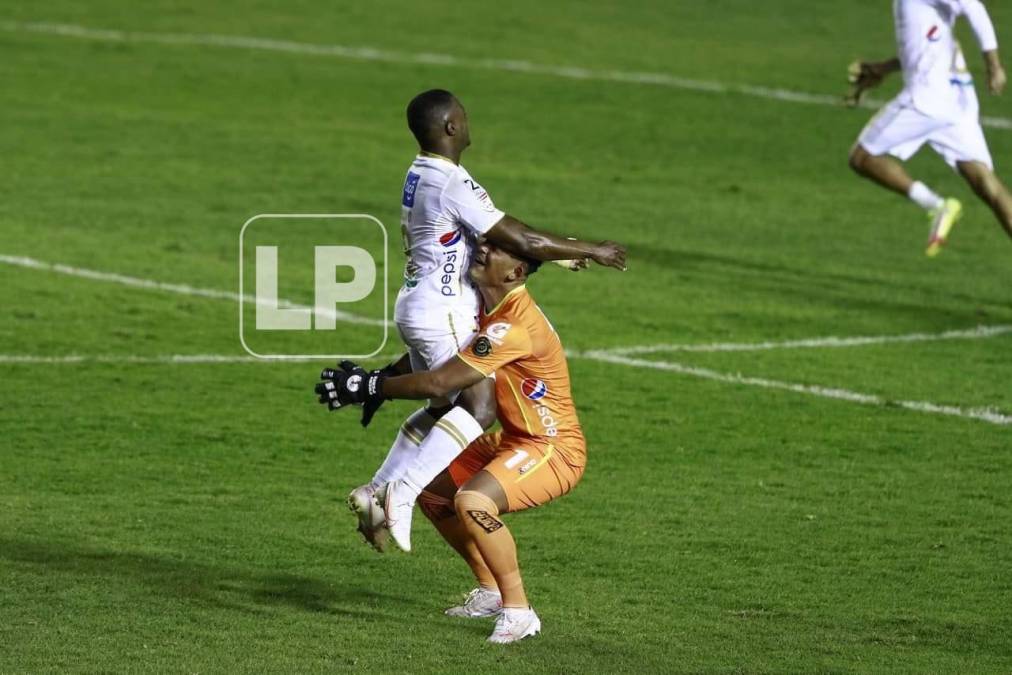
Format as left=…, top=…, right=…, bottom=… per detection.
left=485, top=215, right=625, bottom=271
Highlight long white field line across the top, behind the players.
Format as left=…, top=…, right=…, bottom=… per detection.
left=0, top=21, right=1012, bottom=130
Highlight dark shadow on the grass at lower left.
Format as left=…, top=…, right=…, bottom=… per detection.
left=0, top=537, right=409, bottom=618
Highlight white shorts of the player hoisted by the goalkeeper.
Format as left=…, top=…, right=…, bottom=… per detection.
left=397, top=304, right=478, bottom=407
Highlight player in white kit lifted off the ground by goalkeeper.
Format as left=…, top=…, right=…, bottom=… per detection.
left=348, top=89, right=625, bottom=551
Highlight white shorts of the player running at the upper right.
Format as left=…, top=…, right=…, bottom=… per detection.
left=857, top=99, right=994, bottom=169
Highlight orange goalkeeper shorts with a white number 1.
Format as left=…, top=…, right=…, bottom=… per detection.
left=449, top=431, right=587, bottom=511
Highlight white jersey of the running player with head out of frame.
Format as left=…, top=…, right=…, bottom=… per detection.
left=893, top=0, right=998, bottom=119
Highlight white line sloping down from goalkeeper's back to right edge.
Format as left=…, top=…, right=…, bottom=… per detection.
left=574, top=351, right=1012, bottom=425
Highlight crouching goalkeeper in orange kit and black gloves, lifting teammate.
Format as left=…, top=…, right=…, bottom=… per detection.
left=317, top=243, right=587, bottom=643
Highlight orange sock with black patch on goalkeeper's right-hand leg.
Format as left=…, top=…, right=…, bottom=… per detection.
left=453, top=490, right=528, bottom=608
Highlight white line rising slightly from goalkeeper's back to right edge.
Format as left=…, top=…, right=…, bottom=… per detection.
left=594, top=325, right=1012, bottom=356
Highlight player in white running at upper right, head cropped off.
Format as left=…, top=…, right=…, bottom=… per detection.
left=850, top=0, right=1012, bottom=256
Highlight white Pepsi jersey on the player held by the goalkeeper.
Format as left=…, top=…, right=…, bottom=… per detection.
left=394, top=154, right=505, bottom=325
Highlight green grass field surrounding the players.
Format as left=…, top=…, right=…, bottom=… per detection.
left=0, top=0, right=1012, bottom=673
